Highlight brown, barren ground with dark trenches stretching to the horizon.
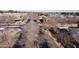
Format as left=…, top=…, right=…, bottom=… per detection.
left=0, top=10, right=79, bottom=48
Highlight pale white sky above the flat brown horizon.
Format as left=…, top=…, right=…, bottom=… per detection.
left=0, top=0, right=79, bottom=11
